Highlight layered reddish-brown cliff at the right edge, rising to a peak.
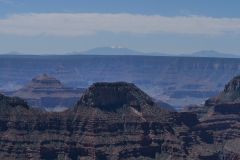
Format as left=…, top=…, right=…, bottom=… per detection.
left=184, top=76, right=240, bottom=160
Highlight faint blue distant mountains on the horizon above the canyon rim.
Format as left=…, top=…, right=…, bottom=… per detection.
left=2, top=47, right=240, bottom=58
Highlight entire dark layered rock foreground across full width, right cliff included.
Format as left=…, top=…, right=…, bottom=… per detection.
left=0, top=77, right=240, bottom=160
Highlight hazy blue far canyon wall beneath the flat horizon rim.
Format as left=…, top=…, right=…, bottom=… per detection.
left=0, top=55, right=240, bottom=107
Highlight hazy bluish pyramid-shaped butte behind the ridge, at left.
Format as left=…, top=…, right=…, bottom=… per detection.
left=3, top=74, right=84, bottom=111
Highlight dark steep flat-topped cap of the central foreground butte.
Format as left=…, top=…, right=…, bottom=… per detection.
left=78, top=82, right=153, bottom=111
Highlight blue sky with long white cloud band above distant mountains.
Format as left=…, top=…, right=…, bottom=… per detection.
left=0, top=0, right=240, bottom=55
